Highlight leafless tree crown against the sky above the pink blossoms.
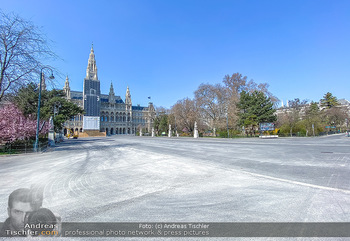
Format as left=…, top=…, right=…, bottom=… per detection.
left=0, top=12, right=57, bottom=101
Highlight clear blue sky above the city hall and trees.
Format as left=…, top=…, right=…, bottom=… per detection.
left=0, top=0, right=350, bottom=107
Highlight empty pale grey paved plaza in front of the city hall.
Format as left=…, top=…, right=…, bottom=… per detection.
left=0, top=135, right=350, bottom=222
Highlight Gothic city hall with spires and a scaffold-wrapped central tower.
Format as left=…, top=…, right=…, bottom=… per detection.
left=63, top=46, right=155, bottom=136
